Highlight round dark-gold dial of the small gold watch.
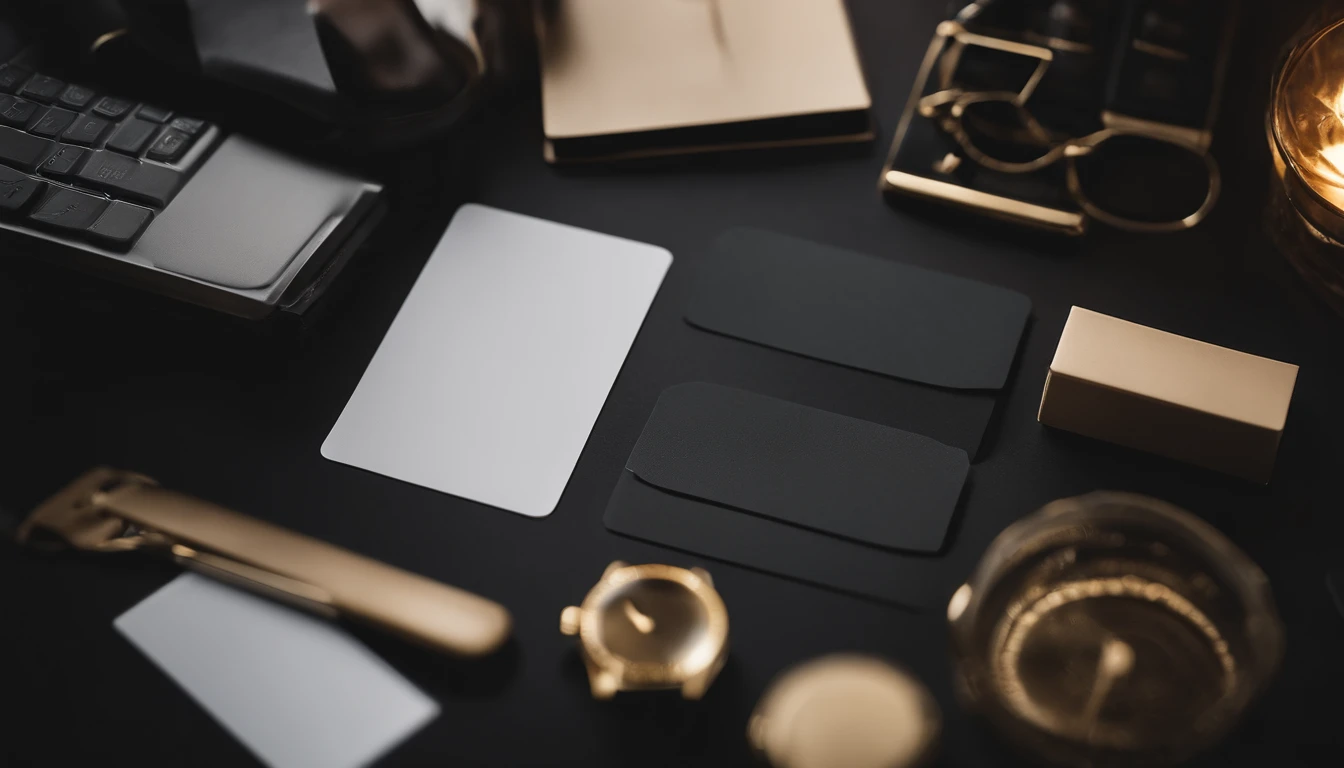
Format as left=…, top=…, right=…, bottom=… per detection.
left=597, top=578, right=712, bottom=668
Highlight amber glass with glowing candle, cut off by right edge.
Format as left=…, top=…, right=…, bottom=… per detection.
left=1266, top=19, right=1344, bottom=312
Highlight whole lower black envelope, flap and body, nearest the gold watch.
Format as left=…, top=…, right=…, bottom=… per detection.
left=605, top=383, right=969, bottom=608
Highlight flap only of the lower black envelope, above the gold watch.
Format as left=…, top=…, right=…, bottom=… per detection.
left=626, top=383, right=970, bottom=553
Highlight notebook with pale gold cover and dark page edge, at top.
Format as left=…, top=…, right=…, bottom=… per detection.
left=538, top=0, right=874, bottom=163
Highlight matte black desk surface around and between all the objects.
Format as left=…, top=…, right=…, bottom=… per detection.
left=0, top=0, right=1344, bottom=767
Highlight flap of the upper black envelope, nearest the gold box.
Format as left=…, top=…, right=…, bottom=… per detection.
left=685, top=229, right=1031, bottom=390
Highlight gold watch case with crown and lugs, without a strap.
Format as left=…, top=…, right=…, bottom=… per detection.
left=560, top=561, right=728, bottom=699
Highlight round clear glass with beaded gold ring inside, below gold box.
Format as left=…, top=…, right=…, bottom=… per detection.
left=948, top=494, right=1282, bottom=767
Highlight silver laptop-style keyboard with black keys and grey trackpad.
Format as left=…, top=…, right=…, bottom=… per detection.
left=0, top=26, right=386, bottom=324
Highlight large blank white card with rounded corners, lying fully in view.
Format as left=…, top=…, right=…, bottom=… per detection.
left=315, top=204, right=672, bottom=518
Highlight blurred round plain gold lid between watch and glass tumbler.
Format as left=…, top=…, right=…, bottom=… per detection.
left=747, top=655, right=941, bottom=768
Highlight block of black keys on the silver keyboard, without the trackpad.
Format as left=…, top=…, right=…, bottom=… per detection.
left=0, top=62, right=218, bottom=250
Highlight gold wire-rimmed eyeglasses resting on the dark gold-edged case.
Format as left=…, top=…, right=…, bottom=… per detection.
left=918, top=22, right=1222, bottom=233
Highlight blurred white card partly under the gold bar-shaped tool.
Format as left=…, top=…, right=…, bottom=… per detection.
left=114, top=573, right=438, bottom=768
